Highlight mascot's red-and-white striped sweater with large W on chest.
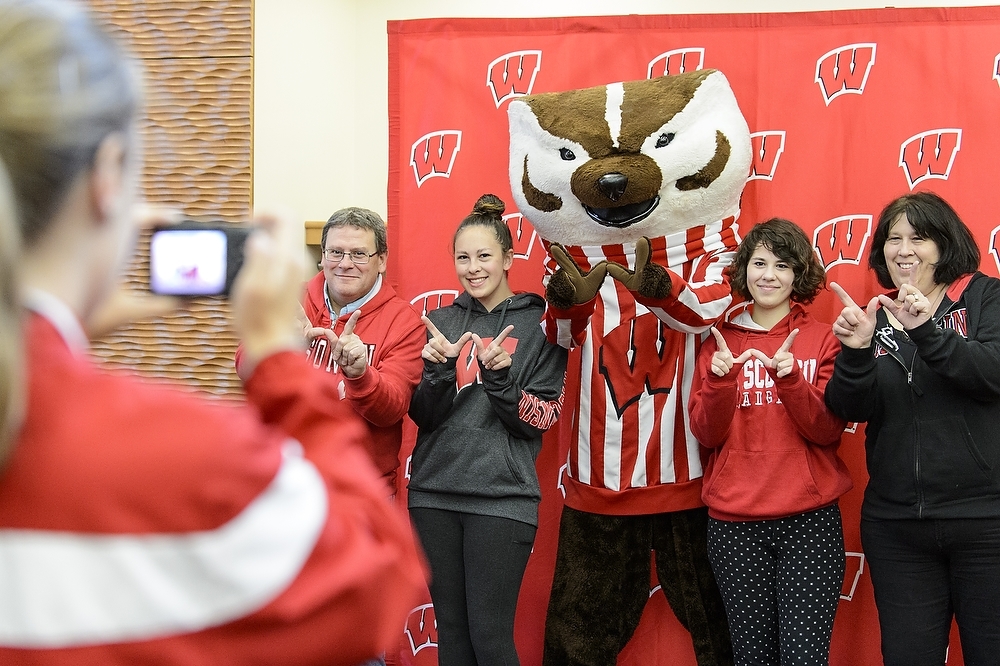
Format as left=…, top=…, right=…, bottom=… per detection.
left=543, top=218, right=737, bottom=515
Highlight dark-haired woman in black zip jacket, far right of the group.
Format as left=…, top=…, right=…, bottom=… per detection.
left=826, top=192, right=1000, bottom=666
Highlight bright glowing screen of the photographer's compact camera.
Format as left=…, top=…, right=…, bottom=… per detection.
left=149, top=229, right=227, bottom=296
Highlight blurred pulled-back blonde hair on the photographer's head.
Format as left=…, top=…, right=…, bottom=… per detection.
left=0, top=0, right=140, bottom=248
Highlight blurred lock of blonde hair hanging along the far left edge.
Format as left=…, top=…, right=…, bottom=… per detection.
left=0, top=157, right=25, bottom=466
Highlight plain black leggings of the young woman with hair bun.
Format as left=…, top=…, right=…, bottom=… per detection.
left=410, top=508, right=536, bottom=666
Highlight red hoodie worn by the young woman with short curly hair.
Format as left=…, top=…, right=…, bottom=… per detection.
left=690, top=303, right=852, bottom=520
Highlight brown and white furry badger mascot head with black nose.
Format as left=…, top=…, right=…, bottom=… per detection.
left=507, top=70, right=751, bottom=245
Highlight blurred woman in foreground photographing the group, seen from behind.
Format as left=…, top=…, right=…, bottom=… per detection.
left=0, top=0, right=423, bottom=666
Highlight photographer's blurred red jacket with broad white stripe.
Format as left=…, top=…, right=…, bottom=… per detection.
left=0, top=304, right=424, bottom=666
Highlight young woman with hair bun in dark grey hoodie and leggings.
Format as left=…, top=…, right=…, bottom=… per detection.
left=409, top=194, right=566, bottom=666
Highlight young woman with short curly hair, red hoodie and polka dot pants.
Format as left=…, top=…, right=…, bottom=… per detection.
left=690, top=218, right=851, bottom=666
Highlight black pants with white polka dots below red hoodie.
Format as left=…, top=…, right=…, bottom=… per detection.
left=708, top=505, right=845, bottom=666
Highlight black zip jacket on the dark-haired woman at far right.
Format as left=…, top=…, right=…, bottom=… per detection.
left=825, top=272, right=1000, bottom=519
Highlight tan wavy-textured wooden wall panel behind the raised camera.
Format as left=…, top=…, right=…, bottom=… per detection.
left=90, top=0, right=253, bottom=399
